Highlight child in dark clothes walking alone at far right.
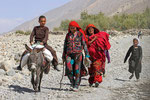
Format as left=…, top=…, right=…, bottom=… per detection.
left=124, top=38, right=142, bottom=81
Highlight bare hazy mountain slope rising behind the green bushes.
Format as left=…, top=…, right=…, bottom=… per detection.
left=13, top=0, right=150, bottom=31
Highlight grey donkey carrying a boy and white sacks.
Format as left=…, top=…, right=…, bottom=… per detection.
left=25, top=45, right=50, bottom=92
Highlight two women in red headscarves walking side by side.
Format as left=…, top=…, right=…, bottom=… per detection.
left=62, top=21, right=111, bottom=91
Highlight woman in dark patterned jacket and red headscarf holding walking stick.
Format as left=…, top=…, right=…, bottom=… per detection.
left=62, top=21, right=89, bottom=91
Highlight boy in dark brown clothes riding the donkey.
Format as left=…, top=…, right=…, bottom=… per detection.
left=17, top=16, right=59, bottom=71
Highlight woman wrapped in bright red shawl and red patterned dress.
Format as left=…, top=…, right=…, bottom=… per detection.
left=85, top=24, right=111, bottom=87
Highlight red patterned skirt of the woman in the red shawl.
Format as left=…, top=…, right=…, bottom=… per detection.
left=88, top=60, right=103, bottom=84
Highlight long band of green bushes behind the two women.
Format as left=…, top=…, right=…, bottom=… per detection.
left=54, top=8, right=150, bottom=31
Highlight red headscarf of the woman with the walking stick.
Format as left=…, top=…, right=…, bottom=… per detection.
left=68, top=21, right=88, bottom=43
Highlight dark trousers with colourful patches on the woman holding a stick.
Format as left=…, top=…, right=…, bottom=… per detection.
left=66, top=53, right=82, bottom=88
